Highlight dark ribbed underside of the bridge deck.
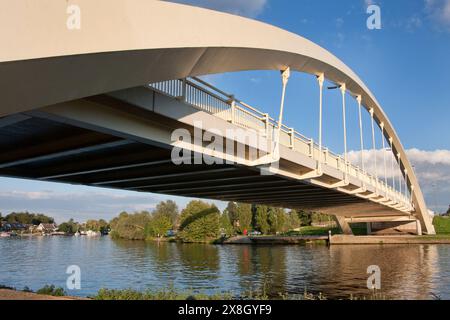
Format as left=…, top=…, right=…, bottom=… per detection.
left=0, top=98, right=408, bottom=220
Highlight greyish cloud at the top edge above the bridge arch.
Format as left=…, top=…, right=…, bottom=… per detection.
left=166, top=0, right=268, bottom=18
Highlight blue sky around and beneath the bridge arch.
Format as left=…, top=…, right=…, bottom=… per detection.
left=0, top=0, right=450, bottom=221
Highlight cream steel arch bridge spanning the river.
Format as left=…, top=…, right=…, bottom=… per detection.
left=0, top=0, right=434, bottom=234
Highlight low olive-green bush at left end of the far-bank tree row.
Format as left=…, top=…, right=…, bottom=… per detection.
left=110, top=211, right=151, bottom=240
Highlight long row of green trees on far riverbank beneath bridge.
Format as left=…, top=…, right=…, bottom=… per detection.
left=109, top=200, right=320, bottom=242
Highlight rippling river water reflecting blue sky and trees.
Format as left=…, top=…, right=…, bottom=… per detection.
left=0, top=237, right=450, bottom=299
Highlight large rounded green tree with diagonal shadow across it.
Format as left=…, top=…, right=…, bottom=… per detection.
left=178, top=200, right=220, bottom=242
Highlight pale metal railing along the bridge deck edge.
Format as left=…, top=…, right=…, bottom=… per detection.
left=148, top=77, right=412, bottom=211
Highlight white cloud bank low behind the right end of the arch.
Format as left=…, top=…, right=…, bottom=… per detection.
left=348, top=148, right=450, bottom=212
